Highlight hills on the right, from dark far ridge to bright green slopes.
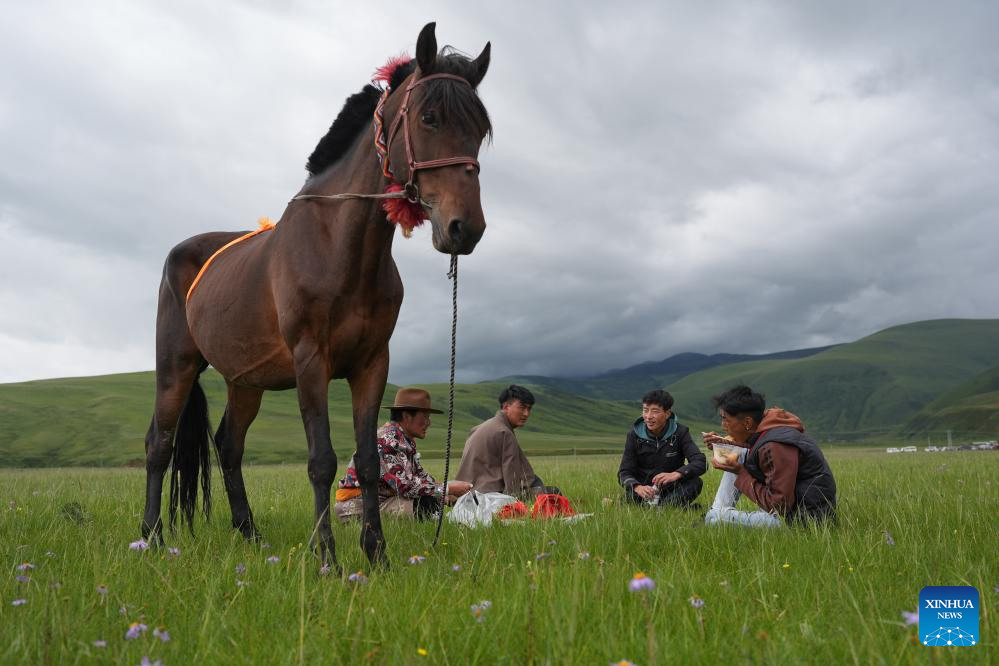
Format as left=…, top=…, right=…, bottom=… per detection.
left=496, top=319, right=999, bottom=436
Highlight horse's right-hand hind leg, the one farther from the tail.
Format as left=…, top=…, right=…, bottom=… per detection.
left=215, top=383, right=263, bottom=540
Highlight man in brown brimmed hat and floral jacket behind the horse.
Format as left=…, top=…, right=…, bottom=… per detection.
left=333, top=388, right=472, bottom=522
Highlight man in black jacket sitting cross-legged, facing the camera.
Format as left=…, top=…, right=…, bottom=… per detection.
left=617, top=389, right=707, bottom=506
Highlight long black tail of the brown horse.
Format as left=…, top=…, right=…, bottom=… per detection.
left=170, top=368, right=212, bottom=533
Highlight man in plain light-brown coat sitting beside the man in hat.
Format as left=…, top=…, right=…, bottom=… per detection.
left=457, top=384, right=561, bottom=497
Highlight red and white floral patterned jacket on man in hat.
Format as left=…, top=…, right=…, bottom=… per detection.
left=337, top=421, right=444, bottom=499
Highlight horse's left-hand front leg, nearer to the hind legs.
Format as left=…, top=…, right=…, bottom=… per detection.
left=294, top=342, right=341, bottom=574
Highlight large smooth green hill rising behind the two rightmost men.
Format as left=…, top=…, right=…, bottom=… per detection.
left=669, top=319, right=999, bottom=433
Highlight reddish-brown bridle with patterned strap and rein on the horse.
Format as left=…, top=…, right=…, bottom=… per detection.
left=291, top=74, right=479, bottom=208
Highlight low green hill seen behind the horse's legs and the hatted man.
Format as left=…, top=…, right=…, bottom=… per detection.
left=0, top=370, right=656, bottom=467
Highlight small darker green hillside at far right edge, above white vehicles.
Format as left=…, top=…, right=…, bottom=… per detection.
left=904, top=366, right=999, bottom=439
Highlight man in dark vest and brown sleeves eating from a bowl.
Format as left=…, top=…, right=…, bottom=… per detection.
left=704, top=386, right=836, bottom=527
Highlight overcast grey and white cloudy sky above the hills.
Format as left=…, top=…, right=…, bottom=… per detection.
left=0, top=0, right=999, bottom=382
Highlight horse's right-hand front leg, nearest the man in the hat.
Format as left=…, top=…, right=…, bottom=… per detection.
left=348, top=349, right=388, bottom=567
